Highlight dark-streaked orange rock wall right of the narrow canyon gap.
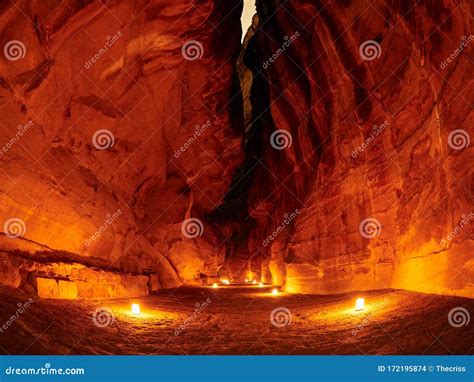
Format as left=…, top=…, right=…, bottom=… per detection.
left=246, top=0, right=474, bottom=297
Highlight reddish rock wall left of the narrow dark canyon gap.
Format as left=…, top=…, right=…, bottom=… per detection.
left=0, top=0, right=242, bottom=294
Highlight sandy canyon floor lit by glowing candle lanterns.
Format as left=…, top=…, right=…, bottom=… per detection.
left=0, top=287, right=474, bottom=355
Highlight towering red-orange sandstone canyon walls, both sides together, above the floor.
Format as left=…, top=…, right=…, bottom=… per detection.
left=0, top=1, right=474, bottom=297
